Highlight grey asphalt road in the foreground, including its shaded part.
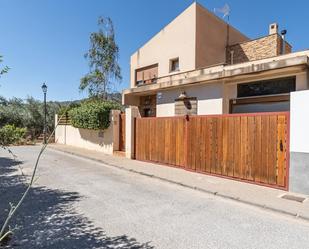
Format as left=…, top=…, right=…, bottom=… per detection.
left=0, top=147, right=309, bottom=249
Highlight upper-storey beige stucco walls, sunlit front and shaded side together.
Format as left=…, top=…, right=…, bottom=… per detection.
left=131, top=3, right=248, bottom=87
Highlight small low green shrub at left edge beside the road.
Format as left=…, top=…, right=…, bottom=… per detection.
left=0, top=125, right=27, bottom=146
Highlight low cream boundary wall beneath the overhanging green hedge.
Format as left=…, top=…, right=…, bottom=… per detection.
left=55, top=125, right=113, bottom=154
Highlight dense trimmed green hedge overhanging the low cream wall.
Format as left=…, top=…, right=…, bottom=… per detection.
left=69, top=100, right=121, bottom=130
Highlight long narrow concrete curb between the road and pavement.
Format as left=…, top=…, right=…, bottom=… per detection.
left=48, top=147, right=309, bottom=222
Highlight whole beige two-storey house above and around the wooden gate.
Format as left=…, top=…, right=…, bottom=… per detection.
left=123, top=3, right=309, bottom=193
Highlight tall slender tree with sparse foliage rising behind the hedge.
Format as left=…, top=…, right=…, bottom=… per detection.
left=79, top=17, right=122, bottom=99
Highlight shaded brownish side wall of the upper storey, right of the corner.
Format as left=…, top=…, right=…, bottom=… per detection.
left=196, top=4, right=248, bottom=68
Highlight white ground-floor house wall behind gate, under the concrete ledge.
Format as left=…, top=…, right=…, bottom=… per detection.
left=157, top=83, right=223, bottom=117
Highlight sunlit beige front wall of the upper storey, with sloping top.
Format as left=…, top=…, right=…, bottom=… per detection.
left=131, top=3, right=196, bottom=87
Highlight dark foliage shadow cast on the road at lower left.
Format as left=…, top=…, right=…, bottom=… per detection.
left=0, top=157, right=153, bottom=249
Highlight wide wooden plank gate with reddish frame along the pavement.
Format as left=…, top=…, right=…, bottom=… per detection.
left=135, top=113, right=289, bottom=189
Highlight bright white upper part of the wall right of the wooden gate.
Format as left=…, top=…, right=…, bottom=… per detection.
left=290, top=90, right=309, bottom=153
